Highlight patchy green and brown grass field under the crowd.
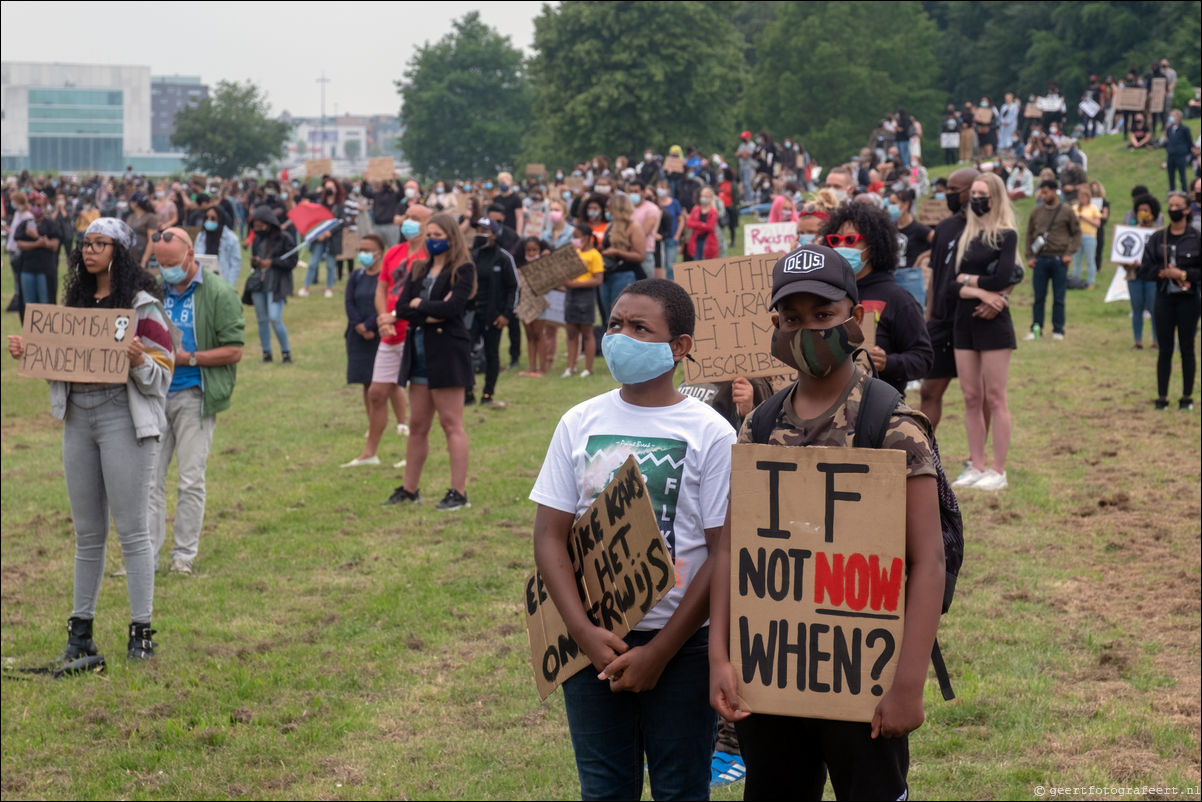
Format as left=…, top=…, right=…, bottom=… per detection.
left=0, top=138, right=1202, bottom=800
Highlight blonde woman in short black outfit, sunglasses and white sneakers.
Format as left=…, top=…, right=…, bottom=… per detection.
left=952, top=173, right=1019, bottom=491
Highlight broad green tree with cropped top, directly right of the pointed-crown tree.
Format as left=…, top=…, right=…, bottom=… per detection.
left=526, top=0, right=744, bottom=165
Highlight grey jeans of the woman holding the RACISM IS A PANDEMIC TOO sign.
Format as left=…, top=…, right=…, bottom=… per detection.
left=63, top=385, right=159, bottom=623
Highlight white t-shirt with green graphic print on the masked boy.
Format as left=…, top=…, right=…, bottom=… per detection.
left=530, top=390, right=736, bottom=631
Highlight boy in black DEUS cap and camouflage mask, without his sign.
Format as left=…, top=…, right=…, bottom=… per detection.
left=706, top=245, right=945, bottom=800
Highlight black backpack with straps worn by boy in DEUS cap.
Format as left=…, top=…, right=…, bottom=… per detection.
left=751, top=376, right=964, bottom=701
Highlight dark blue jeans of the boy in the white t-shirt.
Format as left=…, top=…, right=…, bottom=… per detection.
left=564, top=628, right=716, bottom=800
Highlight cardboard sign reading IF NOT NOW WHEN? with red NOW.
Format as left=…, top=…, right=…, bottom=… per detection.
left=730, top=445, right=906, bottom=721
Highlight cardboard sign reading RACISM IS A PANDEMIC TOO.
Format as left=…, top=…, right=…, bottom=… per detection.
left=17, top=303, right=137, bottom=385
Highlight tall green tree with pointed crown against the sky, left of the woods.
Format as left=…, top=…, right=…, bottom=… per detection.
left=397, top=11, right=530, bottom=178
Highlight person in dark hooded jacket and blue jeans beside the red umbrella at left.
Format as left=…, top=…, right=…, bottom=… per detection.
left=243, top=206, right=297, bottom=364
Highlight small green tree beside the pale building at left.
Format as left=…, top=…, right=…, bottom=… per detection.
left=171, top=81, right=292, bottom=177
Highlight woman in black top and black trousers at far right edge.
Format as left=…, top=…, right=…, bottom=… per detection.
left=1141, top=191, right=1202, bottom=411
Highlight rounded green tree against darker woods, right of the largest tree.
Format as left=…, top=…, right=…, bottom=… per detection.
left=745, top=2, right=941, bottom=165
